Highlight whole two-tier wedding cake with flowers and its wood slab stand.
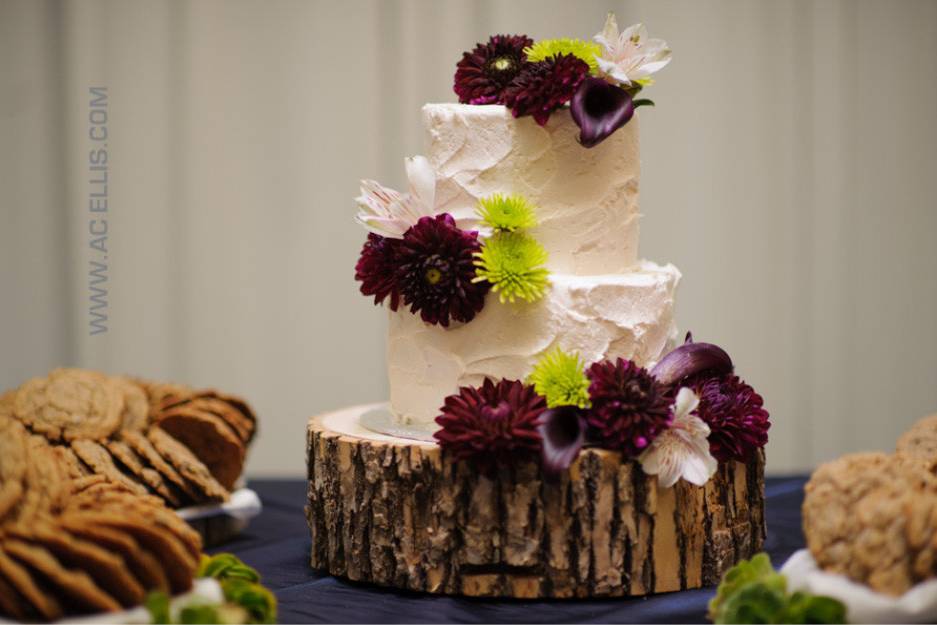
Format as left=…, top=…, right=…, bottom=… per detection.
left=307, top=15, right=770, bottom=597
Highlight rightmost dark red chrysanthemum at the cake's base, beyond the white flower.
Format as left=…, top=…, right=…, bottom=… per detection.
left=690, top=375, right=771, bottom=462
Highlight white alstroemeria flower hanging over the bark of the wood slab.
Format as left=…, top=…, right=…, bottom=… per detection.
left=638, top=387, right=719, bottom=488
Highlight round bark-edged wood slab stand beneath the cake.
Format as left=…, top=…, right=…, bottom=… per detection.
left=306, top=404, right=765, bottom=598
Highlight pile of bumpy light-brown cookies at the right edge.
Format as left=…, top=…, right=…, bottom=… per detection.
left=803, top=415, right=937, bottom=596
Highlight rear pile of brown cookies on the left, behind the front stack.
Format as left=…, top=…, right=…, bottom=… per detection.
left=0, top=369, right=256, bottom=508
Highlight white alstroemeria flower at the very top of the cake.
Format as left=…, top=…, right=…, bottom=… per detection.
left=594, top=13, right=671, bottom=87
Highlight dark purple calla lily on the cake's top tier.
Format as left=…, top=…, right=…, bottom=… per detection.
left=570, top=78, right=634, bottom=148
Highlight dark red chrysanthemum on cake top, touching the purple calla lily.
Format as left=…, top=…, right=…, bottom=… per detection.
left=503, top=54, right=589, bottom=126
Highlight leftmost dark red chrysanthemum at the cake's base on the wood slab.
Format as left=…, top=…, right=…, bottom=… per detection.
left=433, top=379, right=547, bottom=472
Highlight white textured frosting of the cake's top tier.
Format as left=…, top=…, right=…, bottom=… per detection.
left=423, top=104, right=640, bottom=275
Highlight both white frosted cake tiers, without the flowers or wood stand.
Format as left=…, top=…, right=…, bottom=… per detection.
left=387, top=104, right=680, bottom=429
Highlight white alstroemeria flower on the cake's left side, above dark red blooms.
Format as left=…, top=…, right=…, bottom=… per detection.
left=355, top=156, right=436, bottom=239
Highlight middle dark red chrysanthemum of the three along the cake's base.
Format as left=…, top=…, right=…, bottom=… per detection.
left=586, top=358, right=673, bottom=456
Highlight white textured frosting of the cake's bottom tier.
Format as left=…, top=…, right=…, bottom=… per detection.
left=387, top=260, right=680, bottom=429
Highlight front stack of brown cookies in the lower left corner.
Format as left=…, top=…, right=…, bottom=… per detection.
left=0, top=412, right=202, bottom=621
